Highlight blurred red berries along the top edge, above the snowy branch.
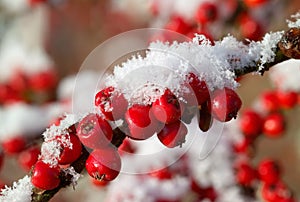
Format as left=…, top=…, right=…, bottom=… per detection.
left=153, top=0, right=268, bottom=41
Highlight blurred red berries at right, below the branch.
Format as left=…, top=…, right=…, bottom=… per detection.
left=234, top=90, right=298, bottom=202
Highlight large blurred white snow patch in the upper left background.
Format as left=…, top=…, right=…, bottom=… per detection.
left=0, top=4, right=54, bottom=82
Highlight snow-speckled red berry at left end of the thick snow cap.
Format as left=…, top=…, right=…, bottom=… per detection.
left=95, top=86, right=128, bottom=121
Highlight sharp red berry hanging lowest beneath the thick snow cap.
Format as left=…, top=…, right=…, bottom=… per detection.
left=157, top=121, right=188, bottom=148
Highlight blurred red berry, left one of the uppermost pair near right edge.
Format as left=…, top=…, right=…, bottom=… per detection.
left=260, top=91, right=279, bottom=112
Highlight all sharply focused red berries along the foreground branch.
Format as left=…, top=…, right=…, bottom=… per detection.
left=28, top=73, right=241, bottom=190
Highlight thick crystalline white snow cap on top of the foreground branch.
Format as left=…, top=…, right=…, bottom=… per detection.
left=106, top=32, right=283, bottom=104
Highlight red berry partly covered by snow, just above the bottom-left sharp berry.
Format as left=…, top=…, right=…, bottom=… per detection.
left=58, top=133, right=82, bottom=165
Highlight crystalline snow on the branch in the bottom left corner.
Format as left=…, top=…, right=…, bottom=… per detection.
left=0, top=175, right=33, bottom=202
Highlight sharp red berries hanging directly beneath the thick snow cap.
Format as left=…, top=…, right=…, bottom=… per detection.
left=95, top=73, right=242, bottom=148
